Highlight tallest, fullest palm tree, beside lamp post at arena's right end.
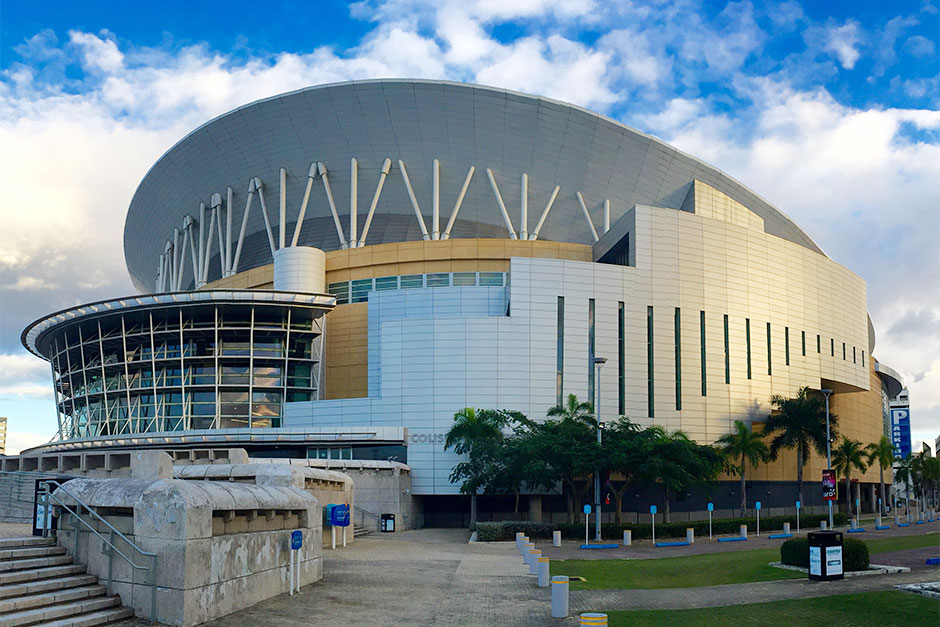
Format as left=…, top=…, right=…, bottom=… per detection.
left=764, top=387, right=838, bottom=502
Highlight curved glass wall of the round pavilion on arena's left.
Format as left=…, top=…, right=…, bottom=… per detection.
left=31, top=293, right=330, bottom=439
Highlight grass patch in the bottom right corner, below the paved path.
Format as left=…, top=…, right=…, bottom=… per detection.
left=608, top=590, right=940, bottom=627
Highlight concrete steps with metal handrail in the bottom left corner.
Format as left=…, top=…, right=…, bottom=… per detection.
left=0, top=538, right=134, bottom=627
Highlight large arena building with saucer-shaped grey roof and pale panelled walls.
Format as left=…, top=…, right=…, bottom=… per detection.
left=23, top=80, right=902, bottom=524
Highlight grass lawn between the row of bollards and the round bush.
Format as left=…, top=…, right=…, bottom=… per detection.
left=550, top=549, right=806, bottom=590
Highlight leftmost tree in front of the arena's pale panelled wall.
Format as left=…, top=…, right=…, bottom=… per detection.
left=444, top=407, right=507, bottom=527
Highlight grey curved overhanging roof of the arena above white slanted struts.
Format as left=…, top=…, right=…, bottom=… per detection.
left=124, top=80, right=822, bottom=292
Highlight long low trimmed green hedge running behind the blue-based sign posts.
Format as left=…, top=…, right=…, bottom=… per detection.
left=474, top=512, right=848, bottom=542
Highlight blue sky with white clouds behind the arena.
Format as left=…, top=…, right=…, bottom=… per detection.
left=0, top=0, right=940, bottom=446
